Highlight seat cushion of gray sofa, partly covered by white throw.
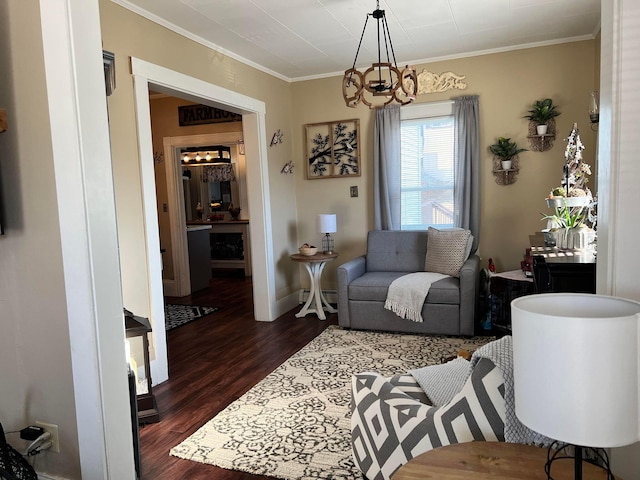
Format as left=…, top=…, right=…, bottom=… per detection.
left=348, top=272, right=460, bottom=305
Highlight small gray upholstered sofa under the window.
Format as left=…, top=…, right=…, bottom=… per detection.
left=337, top=230, right=480, bottom=335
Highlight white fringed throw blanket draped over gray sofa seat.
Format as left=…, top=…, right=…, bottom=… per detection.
left=384, top=272, right=449, bottom=322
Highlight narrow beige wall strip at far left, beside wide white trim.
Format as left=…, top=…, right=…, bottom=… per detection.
left=0, top=1, right=80, bottom=478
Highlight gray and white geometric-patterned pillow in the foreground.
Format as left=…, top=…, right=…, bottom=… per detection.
left=351, top=358, right=505, bottom=480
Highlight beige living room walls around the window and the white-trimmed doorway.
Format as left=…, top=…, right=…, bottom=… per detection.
left=101, top=1, right=596, bottom=304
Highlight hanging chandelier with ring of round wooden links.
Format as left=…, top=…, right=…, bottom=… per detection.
left=342, top=0, right=418, bottom=108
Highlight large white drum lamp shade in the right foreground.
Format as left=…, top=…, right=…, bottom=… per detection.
left=511, top=293, right=640, bottom=448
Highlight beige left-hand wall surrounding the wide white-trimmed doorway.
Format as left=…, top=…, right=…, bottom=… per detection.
left=100, top=0, right=298, bottom=315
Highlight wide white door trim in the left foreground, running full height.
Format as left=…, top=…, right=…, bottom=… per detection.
left=38, top=0, right=135, bottom=480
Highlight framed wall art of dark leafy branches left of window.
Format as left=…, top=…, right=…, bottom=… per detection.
left=305, top=119, right=360, bottom=180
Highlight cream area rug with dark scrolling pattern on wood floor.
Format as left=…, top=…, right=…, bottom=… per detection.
left=171, top=326, right=494, bottom=480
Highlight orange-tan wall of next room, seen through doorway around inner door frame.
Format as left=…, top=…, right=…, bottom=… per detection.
left=149, top=97, right=246, bottom=280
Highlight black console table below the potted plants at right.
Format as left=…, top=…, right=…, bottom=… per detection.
left=529, top=233, right=596, bottom=293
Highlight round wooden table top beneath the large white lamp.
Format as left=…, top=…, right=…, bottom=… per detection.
left=392, top=442, right=621, bottom=480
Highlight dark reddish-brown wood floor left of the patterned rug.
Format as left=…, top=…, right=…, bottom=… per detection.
left=140, top=271, right=337, bottom=480
